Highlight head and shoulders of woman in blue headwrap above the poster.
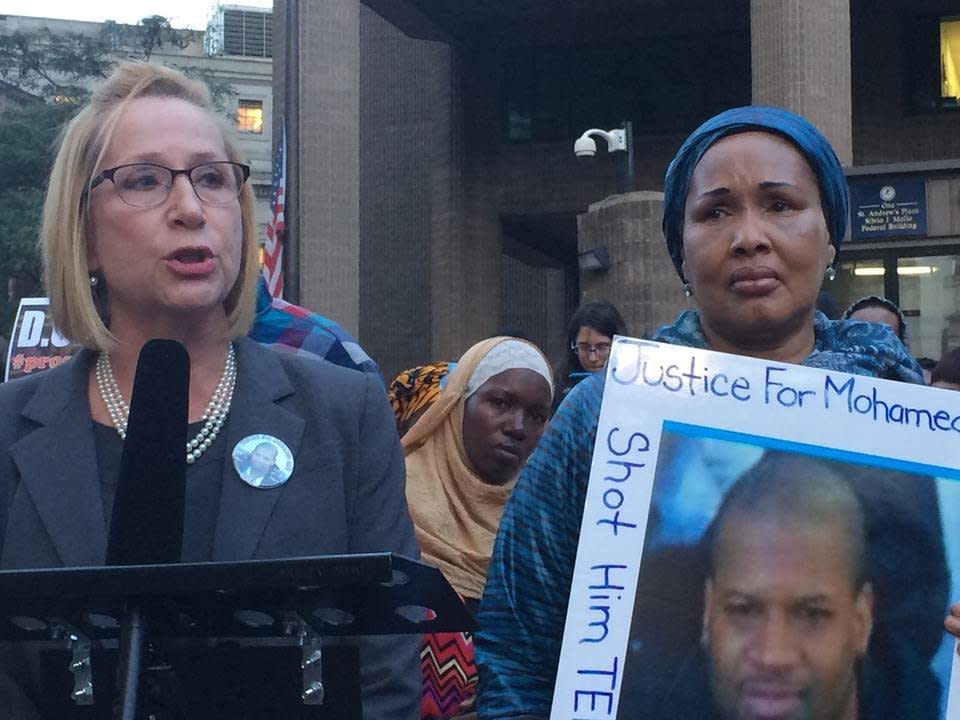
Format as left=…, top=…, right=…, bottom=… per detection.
left=654, top=106, right=923, bottom=383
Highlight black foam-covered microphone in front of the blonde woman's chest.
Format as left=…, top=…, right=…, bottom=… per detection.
left=107, top=340, right=190, bottom=565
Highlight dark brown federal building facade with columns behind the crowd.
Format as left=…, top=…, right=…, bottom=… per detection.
left=274, top=0, right=960, bottom=382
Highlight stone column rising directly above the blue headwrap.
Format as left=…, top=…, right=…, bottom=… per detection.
left=750, top=0, right=853, bottom=165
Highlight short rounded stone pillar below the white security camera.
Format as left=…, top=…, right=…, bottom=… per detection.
left=577, top=191, right=692, bottom=336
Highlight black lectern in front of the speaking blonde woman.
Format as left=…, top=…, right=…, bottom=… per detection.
left=0, top=553, right=473, bottom=720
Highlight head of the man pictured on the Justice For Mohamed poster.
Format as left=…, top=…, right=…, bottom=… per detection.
left=702, top=455, right=873, bottom=720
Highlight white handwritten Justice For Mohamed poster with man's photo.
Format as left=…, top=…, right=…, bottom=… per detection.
left=551, top=338, right=960, bottom=720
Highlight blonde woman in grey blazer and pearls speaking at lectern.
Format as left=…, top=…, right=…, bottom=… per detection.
left=0, top=63, right=420, bottom=719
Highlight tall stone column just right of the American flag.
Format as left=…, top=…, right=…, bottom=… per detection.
left=274, top=0, right=360, bottom=333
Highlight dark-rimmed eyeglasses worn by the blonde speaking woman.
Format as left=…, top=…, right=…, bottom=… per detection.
left=90, top=161, right=250, bottom=208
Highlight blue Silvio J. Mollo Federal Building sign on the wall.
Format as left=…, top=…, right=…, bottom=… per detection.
left=850, top=180, right=927, bottom=240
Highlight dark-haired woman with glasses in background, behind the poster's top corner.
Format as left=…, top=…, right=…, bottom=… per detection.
left=554, top=300, right=627, bottom=408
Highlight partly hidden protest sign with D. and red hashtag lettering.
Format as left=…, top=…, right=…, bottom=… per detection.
left=4, top=298, right=78, bottom=381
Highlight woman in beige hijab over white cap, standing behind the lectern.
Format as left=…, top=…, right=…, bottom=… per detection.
left=403, top=337, right=553, bottom=720
